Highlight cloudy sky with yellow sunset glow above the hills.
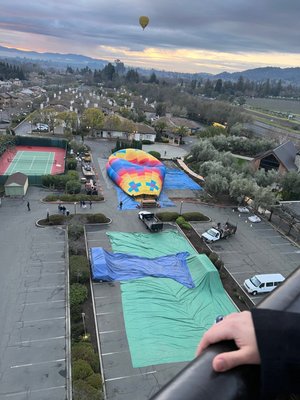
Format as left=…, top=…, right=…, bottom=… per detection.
left=0, top=0, right=300, bottom=74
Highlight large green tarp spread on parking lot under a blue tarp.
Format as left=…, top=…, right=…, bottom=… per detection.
left=108, top=231, right=237, bottom=368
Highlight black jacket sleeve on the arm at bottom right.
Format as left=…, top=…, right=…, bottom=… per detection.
left=251, top=308, right=300, bottom=398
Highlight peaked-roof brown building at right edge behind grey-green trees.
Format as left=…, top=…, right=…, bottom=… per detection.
left=252, top=141, right=299, bottom=175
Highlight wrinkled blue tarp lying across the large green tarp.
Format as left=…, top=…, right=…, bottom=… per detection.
left=90, top=247, right=195, bottom=289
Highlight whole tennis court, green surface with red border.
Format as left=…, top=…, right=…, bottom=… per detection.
left=0, top=146, right=65, bottom=176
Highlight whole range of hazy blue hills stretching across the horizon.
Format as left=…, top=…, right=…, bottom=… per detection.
left=0, top=46, right=300, bottom=85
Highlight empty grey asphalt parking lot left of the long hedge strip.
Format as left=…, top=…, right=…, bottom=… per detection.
left=0, top=196, right=69, bottom=400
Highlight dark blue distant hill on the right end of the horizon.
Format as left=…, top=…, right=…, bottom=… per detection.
left=214, top=67, right=300, bottom=85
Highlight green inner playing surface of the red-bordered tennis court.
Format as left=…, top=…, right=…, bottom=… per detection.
left=5, top=151, right=55, bottom=175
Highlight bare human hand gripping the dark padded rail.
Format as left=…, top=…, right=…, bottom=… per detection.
left=197, top=311, right=260, bottom=372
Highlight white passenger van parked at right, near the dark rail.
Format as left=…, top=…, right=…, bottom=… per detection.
left=244, top=274, right=285, bottom=296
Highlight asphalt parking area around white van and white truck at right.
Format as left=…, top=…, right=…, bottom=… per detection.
left=193, top=206, right=300, bottom=304
